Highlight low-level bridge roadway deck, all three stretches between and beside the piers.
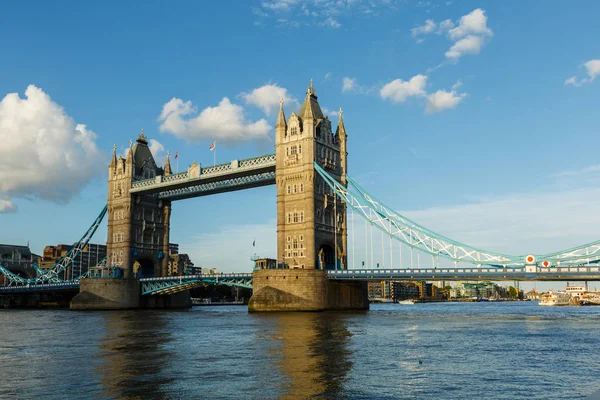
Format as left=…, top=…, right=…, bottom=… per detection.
left=0, top=266, right=600, bottom=295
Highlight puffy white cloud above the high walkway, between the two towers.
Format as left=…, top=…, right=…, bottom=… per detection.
left=158, top=97, right=272, bottom=142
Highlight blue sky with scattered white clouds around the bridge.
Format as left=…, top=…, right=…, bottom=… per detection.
left=0, top=0, right=600, bottom=288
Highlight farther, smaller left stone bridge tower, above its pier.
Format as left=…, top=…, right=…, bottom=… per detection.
left=106, top=131, right=171, bottom=278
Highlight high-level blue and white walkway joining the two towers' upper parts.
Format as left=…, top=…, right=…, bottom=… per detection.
left=130, top=154, right=275, bottom=200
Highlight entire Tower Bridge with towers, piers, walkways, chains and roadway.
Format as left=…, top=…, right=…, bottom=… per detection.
left=0, top=82, right=600, bottom=311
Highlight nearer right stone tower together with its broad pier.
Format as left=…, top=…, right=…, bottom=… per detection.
left=248, top=81, right=369, bottom=311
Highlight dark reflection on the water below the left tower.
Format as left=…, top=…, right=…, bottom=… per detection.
left=97, top=311, right=176, bottom=399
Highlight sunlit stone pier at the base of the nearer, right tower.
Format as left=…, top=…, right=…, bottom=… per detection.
left=248, top=269, right=369, bottom=312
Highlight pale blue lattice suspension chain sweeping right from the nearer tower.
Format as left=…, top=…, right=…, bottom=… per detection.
left=314, top=163, right=600, bottom=268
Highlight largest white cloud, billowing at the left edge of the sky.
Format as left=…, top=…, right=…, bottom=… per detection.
left=0, top=85, right=106, bottom=212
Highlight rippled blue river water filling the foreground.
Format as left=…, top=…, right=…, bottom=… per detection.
left=0, top=302, right=600, bottom=400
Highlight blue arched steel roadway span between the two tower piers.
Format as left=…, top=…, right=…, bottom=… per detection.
left=140, top=273, right=252, bottom=295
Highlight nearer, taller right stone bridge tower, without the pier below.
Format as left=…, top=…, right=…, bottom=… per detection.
left=275, top=82, right=347, bottom=270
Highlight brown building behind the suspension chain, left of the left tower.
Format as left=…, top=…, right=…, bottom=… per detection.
left=39, top=243, right=106, bottom=280
